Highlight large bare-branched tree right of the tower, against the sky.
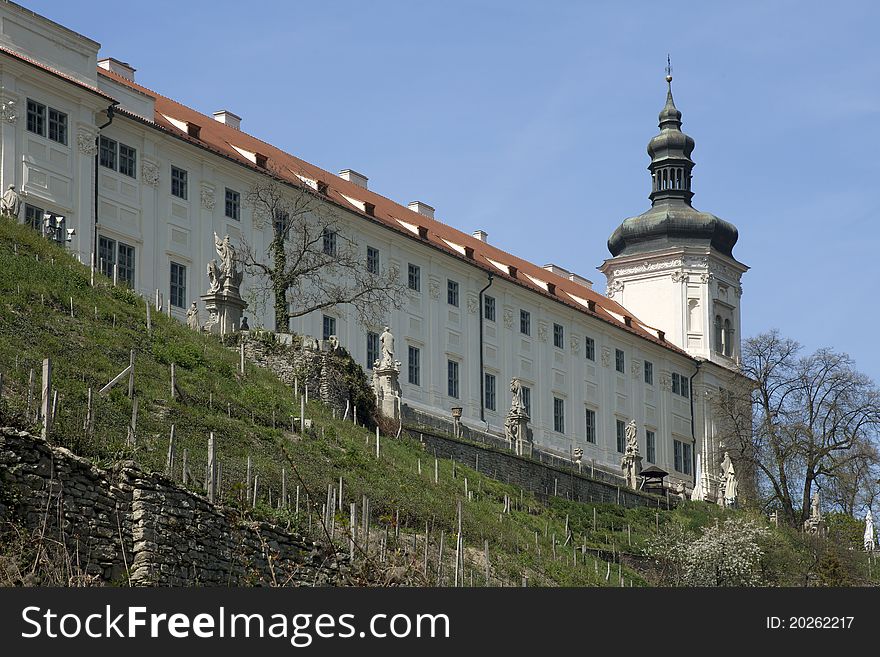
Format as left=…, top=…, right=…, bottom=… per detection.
left=715, top=331, right=880, bottom=526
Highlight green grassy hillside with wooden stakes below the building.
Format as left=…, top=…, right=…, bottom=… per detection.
left=0, top=219, right=868, bottom=586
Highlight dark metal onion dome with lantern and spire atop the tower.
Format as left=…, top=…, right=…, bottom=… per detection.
left=608, top=69, right=739, bottom=257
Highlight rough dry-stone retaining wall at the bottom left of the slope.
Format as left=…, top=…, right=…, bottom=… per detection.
left=0, top=428, right=348, bottom=586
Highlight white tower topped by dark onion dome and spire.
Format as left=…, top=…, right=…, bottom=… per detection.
left=599, top=67, right=748, bottom=368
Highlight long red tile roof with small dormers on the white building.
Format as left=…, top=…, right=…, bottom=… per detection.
left=98, top=68, right=691, bottom=358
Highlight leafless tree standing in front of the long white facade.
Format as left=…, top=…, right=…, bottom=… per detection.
left=242, top=179, right=404, bottom=331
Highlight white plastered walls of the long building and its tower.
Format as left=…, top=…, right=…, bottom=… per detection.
left=0, top=4, right=745, bottom=492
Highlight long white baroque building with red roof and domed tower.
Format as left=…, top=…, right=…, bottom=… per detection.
left=0, top=2, right=746, bottom=495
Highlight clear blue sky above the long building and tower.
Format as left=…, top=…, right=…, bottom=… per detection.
left=25, top=0, right=880, bottom=381
